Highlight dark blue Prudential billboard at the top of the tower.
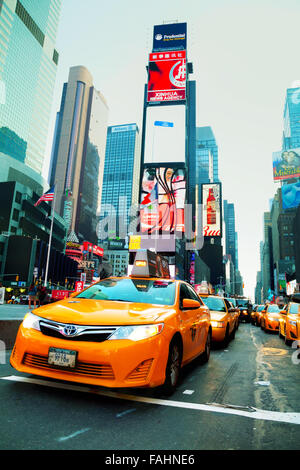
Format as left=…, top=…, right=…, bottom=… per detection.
left=153, top=23, right=187, bottom=52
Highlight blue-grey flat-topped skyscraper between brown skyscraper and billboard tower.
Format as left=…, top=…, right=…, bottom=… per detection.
left=101, top=123, right=140, bottom=238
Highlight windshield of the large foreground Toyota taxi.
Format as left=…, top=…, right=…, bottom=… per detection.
left=76, top=278, right=176, bottom=305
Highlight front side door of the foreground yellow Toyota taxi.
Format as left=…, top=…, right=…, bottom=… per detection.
left=179, top=283, right=206, bottom=362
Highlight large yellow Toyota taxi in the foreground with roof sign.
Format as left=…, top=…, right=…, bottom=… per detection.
left=10, top=250, right=212, bottom=394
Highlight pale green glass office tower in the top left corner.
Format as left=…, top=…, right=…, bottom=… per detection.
left=0, top=0, right=61, bottom=174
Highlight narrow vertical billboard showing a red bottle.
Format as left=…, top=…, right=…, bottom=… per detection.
left=202, top=183, right=222, bottom=237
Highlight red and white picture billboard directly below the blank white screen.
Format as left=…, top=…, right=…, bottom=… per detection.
left=140, top=167, right=186, bottom=234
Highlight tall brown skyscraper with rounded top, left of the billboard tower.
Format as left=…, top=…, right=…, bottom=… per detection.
left=49, top=66, right=108, bottom=243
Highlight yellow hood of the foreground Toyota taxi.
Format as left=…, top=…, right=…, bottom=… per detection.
left=33, top=298, right=175, bottom=325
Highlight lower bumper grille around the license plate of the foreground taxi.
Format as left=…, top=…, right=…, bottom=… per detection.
left=23, top=353, right=115, bottom=380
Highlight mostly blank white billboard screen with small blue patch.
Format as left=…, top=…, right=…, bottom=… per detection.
left=144, top=104, right=186, bottom=164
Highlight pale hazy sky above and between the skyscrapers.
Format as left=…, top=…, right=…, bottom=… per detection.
left=44, top=0, right=300, bottom=298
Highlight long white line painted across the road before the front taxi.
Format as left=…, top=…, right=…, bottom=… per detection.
left=1, top=375, right=300, bottom=424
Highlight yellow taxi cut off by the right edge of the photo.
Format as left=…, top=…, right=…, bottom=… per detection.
left=279, top=302, right=300, bottom=346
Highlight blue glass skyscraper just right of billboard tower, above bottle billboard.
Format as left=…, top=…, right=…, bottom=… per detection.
left=196, top=126, right=219, bottom=183
